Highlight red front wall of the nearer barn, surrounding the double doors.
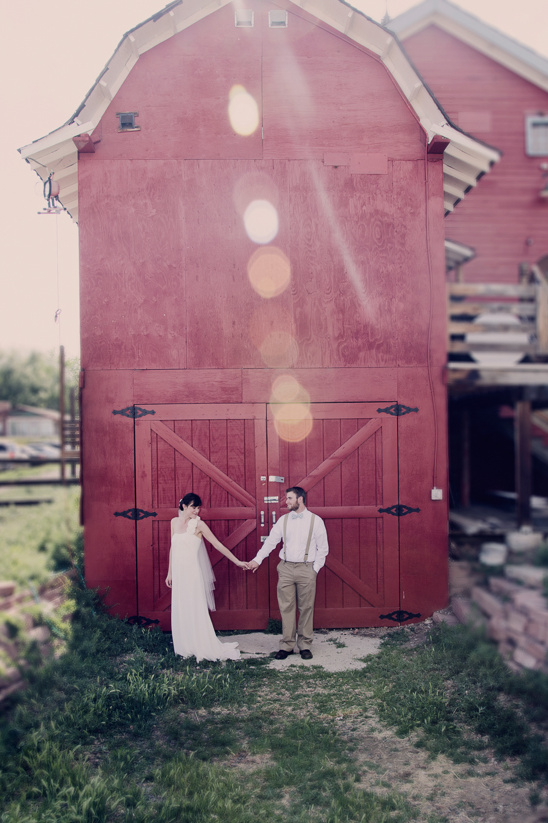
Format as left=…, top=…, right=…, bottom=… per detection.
left=79, top=2, right=447, bottom=615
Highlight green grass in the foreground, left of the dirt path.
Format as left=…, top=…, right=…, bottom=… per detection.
left=0, top=605, right=439, bottom=823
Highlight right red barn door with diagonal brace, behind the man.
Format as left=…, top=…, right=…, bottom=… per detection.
left=268, top=403, right=399, bottom=628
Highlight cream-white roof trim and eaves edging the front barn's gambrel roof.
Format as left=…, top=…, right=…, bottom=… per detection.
left=19, top=0, right=500, bottom=221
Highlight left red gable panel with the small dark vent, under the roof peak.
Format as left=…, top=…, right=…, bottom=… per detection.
left=88, top=1, right=262, bottom=160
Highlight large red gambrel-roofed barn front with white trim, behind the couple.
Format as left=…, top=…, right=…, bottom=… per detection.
left=22, top=0, right=498, bottom=629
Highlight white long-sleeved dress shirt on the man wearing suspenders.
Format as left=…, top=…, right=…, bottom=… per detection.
left=254, top=509, right=329, bottom=574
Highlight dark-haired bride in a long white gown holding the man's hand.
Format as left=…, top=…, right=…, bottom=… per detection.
left=166, top=492, right=248, bottom=661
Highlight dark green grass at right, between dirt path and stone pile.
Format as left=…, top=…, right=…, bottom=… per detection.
left=368, top=625, right=548, bottom=780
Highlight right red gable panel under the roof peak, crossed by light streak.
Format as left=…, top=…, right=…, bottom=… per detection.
left=261, top=5, right=424, bottom=159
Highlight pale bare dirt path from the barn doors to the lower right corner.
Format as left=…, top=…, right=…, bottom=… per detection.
left=224, top=621, right=548, bottom=823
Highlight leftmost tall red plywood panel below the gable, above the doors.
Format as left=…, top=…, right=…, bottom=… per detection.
left=79, top=158, right=187, bottom=369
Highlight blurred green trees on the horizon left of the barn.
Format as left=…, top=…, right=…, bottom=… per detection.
left=0, top=351, right=80, bottom=409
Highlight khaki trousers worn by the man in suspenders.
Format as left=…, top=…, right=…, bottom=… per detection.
left=277, top=560, right=316, bottom=652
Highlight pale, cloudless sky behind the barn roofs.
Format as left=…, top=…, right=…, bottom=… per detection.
left=0, top=0, right=548, bottom=356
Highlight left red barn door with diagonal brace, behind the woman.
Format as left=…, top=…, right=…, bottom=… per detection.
left=135, top=404, right=268, bottom=629
